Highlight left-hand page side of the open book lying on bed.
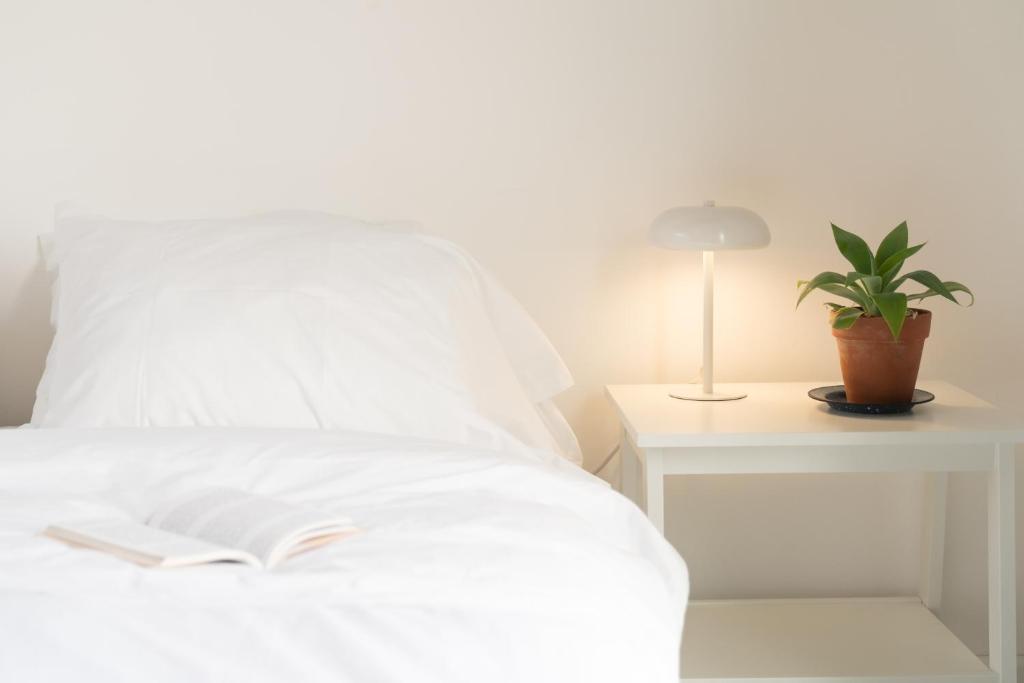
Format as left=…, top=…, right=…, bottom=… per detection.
left=43, top=519, right=259, bottom=566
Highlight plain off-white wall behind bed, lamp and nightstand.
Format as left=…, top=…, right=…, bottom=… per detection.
left=0, top=0, right=1024, bottom=652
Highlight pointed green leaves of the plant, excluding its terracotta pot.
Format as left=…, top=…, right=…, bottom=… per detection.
left=797, top=221, right=974, bottom=339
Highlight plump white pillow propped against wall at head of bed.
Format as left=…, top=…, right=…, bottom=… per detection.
left=32, top=212, right=579, bottom=460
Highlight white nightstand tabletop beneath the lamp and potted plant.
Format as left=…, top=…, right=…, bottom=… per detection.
left=607, top=381, right=1024, bottom=447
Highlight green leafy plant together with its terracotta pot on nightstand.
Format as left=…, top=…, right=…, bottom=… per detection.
left=797, top=221, right=974, bottom=404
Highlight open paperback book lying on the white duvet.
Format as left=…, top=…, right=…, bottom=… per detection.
left=43, top=488, right=357, bottom=569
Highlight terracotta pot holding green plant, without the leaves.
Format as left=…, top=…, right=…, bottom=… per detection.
left=833, top=308, right=932, bottom=403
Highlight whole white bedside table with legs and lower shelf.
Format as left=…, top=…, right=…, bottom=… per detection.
left=607, top=382, right=1024, bottom=683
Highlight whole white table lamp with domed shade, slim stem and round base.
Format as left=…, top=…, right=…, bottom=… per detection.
left=650, top=197, right=771, bottom=400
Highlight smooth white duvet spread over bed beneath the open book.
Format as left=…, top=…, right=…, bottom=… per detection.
left=0, top=429, right=687, bottom=683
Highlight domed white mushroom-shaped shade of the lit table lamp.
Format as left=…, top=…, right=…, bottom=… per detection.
left=650, top=202, right=771, bottom=251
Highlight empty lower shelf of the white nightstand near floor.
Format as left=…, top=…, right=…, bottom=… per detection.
left=681, top=597, right=996, bottom=683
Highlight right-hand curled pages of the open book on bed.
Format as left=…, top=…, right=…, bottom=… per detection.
left=147, top=487, right=354, bottom=567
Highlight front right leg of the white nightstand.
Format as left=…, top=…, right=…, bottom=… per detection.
left=988, top=443, right=1017, bottom=683
